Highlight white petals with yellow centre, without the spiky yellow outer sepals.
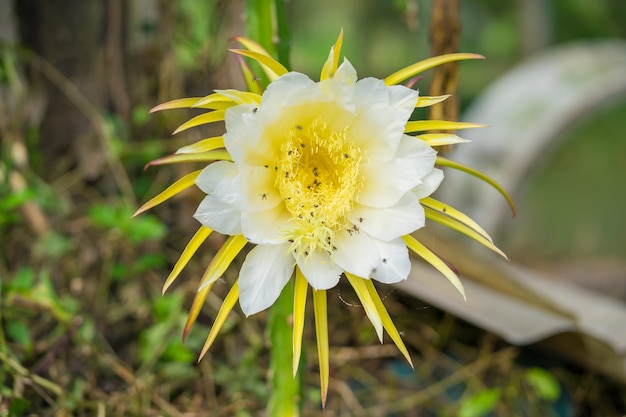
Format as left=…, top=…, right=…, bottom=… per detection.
left=194, top=60, right=443, bottom=315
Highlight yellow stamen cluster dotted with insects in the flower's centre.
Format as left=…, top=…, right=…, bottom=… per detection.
left=275, top=119, right=363, bottom=257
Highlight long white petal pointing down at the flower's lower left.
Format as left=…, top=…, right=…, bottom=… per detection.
left=239, top=244, right=295, bottom=316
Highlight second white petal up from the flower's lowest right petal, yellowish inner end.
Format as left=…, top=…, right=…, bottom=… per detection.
left=356, top=158, right=421, bottom=207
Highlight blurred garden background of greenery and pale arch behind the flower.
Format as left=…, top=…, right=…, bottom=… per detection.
left=0, top=0, right=626, bottom=417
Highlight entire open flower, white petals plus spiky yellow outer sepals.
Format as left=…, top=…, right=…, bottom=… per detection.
left=137, top=29, right=510, bottom=401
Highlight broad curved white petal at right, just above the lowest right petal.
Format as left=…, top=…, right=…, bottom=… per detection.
left=349, top=192, right=425, bottom=241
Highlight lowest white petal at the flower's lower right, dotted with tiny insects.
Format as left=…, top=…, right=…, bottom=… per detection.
left=369, top=238, right=411, bottom=284
